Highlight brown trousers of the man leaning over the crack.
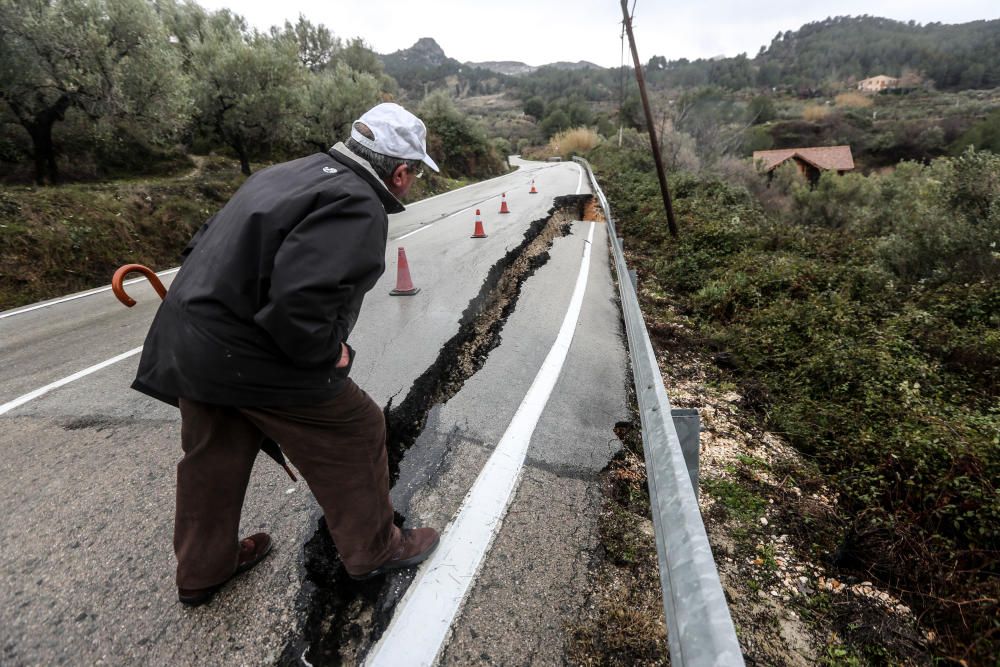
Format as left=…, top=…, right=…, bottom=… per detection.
left=174, top=380, right=399, bottom=589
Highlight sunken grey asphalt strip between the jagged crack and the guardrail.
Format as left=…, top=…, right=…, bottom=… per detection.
left=397, top=222, right=628, bottom=665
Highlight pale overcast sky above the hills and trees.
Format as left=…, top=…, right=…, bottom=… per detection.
left=191, top=0, right=1000, bottom=67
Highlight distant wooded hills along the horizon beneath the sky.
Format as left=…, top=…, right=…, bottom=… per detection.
left=380, top=16, right=1000, bottom=100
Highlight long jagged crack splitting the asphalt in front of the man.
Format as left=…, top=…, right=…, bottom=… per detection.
left=278, top=195, right=602, bottom=667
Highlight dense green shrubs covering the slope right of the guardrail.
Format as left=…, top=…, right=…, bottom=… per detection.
left=592, top=144, right=1000, bottom=661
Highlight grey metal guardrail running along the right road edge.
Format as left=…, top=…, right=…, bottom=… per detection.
left=573, top=157, right=744, bottom=667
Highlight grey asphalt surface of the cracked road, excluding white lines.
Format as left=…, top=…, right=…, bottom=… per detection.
left=0, top=160, right=627, bottom=665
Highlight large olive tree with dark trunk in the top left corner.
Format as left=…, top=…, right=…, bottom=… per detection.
left=0, top=0, right=188, bottom=184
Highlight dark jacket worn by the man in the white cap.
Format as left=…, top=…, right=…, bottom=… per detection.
left=132, top=144, right=403, bottom=407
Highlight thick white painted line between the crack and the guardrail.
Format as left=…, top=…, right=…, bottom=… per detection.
left=365, top=222, right=594, bottom=667
